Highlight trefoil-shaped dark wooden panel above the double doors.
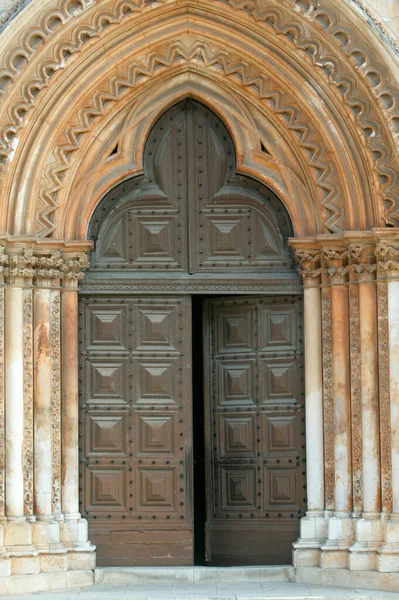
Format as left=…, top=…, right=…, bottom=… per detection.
left=90, top=100, right=292, bottom=279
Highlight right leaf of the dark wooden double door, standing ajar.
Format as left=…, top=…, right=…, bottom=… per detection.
left=204, top=297, right=306, bottom=565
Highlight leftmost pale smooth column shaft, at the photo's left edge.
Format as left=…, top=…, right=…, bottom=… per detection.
left=5, top=286, right=24, bottom=517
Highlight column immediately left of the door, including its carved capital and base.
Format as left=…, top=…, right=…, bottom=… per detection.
left=61, top=253, right=95, bottom=568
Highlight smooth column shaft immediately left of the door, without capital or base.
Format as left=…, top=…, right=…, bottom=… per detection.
left=61, top=288, right=79, bottom=516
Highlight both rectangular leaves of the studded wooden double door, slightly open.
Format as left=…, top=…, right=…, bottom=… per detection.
left=80, top=295, right=306, bottom=566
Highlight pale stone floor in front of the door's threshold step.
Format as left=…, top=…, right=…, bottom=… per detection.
left=2, top=581, right=399, bottom=600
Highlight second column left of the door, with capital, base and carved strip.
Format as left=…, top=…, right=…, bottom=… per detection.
left=33, top=249, right=66, bottom=552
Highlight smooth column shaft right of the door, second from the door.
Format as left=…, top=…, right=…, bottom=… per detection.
left=331, top=283, right=352, bottom=512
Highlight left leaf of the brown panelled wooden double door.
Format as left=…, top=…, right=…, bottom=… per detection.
left=80, top=296, right=193, bottom=566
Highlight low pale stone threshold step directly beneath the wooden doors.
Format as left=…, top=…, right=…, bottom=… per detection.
left=95, top=565, right=294, bottom=584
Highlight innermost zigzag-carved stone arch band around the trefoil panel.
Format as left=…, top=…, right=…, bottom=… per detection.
left=36, top=41, right=344, bottom=236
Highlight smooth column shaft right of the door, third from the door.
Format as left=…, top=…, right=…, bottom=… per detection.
left=359, top=281, right=381, bottom=513
